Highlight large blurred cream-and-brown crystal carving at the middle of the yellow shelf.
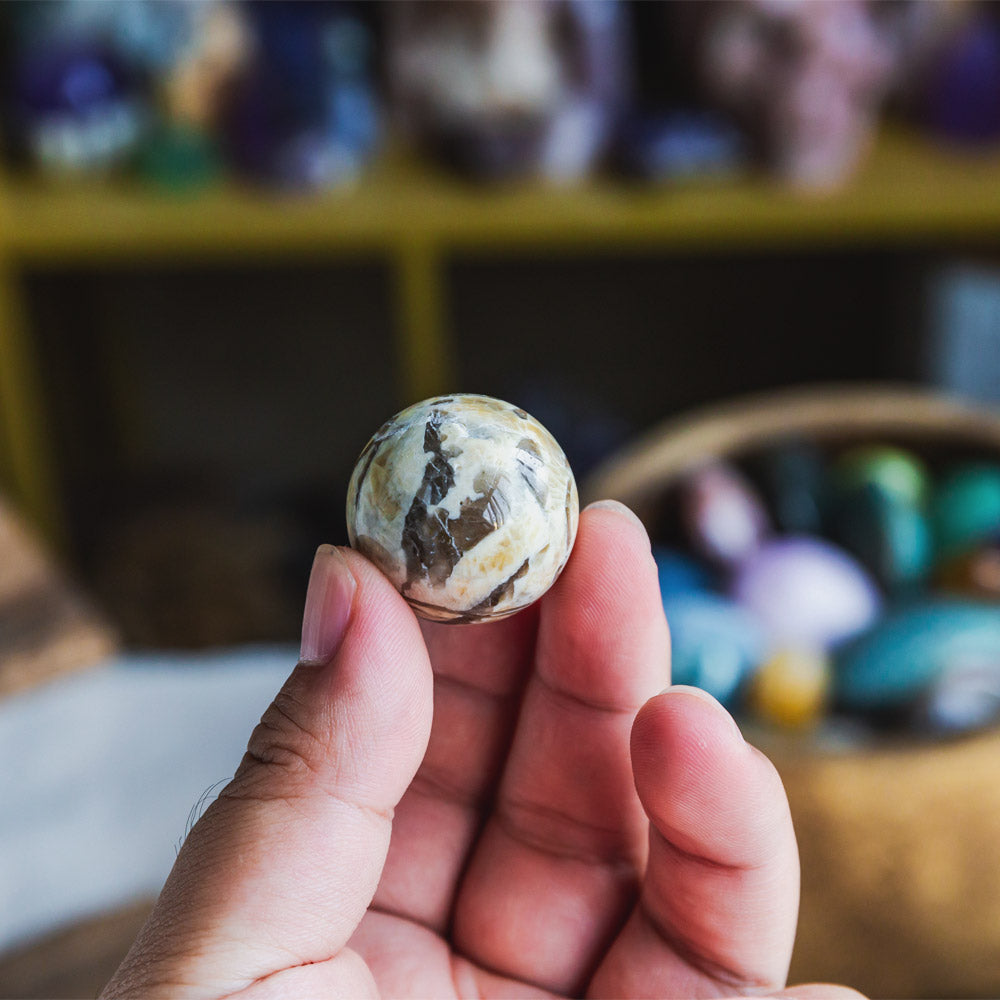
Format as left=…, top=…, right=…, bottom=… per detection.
left=386, top=0, right=626, bottom=181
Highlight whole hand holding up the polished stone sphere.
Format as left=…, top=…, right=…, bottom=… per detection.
left=104, top=503, right=864, bottom=1000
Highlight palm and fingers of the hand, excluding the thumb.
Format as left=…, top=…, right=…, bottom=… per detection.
left=351, top=512, right=798, bottom=997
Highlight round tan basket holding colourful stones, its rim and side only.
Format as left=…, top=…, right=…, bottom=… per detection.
left=582, top=386, right=1000, bottom=997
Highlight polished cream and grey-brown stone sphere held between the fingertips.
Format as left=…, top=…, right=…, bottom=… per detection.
left=347, top=395, right=579, bottom=622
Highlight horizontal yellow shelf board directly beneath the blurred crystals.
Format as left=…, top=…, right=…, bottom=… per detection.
left=0, top=135, right=1000, bottom=264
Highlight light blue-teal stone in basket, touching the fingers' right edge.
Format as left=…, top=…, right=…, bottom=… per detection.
left=663, top=593, right=767, bottom=704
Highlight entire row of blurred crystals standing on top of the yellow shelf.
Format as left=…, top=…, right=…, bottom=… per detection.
left=0, top=0, right=1000, bottom=191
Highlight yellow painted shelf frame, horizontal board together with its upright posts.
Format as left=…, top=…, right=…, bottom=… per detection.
left=0, top=133, right=1000, bottom=538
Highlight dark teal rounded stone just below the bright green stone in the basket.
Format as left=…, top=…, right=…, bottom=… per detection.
left=837, top=483, right=934, bottom=593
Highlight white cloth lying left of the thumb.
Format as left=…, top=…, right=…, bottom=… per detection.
left=0, top=646, right=297, bottom=951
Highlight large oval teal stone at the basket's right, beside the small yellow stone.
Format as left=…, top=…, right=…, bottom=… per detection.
left=834, top=599, right=1000, bottom=711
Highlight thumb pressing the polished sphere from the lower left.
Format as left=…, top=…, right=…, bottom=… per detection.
left=104, top=545, right=432, bottom=998
